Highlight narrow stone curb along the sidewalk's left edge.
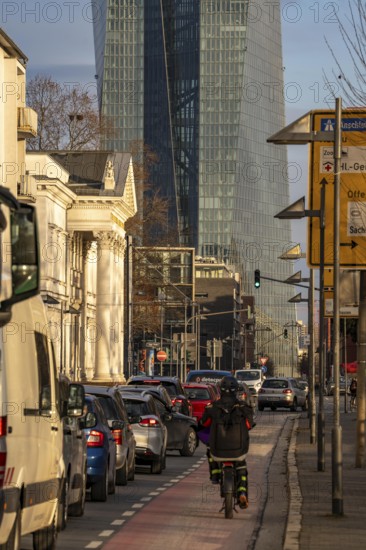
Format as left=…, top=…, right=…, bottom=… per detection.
left=283, top=419, right=303, bottom=550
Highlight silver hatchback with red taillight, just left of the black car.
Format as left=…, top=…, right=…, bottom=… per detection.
left=121, top=391, right=168, bottom=474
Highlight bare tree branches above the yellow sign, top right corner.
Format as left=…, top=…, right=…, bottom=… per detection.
left=324, top=0, right=366, bottom=107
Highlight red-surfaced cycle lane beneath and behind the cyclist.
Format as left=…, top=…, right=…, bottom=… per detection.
left=103, top=463, right=260, bottom=550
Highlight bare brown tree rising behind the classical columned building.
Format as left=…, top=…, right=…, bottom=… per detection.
left=27, top=75, right=111, bottom=151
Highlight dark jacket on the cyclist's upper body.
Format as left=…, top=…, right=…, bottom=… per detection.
left=200, top=398, right=253, bottom=459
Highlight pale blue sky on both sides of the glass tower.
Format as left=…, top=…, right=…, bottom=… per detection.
left=0, top=0, right=353, bottom=324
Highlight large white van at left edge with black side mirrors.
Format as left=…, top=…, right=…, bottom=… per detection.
left=0, top=196, right=84, bottom=550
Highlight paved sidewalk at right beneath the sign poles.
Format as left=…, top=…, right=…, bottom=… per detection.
left=284, top=400, right=366, bottom=550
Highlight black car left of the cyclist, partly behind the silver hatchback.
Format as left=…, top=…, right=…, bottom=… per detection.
left=120, top=386, right=198, bottom=456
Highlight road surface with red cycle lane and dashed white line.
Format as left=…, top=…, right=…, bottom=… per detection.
left=21, top=410, right=300, bottom=550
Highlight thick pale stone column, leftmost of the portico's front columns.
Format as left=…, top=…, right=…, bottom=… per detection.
left=94, top=231, right=115, bottom=382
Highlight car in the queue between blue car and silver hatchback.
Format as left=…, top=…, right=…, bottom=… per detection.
left=84, top=385, right=136, bottom=485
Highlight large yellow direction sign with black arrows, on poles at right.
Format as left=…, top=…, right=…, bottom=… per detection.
left=307, top=109, right=366, bottom=269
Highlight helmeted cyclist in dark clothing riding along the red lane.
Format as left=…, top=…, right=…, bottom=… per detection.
left=198, top=376, right=255, bottom=508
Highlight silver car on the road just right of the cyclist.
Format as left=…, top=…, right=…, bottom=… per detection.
left=258, top=378, right=307, bottom=411
